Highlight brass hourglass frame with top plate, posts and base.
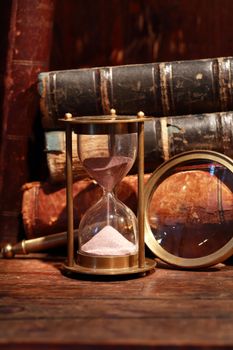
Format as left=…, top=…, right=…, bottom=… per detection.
left=60, top=110, right=156, bottom=275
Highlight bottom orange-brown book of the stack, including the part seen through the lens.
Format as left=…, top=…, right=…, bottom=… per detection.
left=22, top=169, right=233, bottom=238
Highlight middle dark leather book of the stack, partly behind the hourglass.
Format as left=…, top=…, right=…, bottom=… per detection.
left=45, top=112, right=233, bottom=182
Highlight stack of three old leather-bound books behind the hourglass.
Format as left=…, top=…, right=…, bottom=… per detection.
left=22, top=57, right=233, bottom=238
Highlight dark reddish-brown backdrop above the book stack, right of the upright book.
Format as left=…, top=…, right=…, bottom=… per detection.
left=51, top=0, right=233, bottom=69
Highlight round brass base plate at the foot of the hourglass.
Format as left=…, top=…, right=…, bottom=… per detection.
left=62, top=259, right=156, bottom=276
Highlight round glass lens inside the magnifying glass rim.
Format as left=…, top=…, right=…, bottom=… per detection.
left=148, top=160, right=233, bottom=258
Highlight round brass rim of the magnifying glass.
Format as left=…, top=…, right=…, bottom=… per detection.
left=144, top=150, right=233, bottom=268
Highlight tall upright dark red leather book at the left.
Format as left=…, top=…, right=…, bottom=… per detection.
left=0, top=0, right=54, bottom=244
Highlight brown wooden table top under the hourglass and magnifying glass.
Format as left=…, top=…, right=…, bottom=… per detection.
left=0, top=258, right=233, bottom=350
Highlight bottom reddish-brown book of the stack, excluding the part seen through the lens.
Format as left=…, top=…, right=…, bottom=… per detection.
left=22, top=175, right=149, bottom=238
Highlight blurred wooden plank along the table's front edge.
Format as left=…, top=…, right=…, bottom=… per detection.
left=0, top=315, right=233, bottom=347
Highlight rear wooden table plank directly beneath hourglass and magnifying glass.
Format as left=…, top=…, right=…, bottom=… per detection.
left=0, top=259, right=233, bottom=299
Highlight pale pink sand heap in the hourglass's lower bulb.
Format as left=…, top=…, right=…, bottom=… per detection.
left=82, top=225, right=136, bottom=255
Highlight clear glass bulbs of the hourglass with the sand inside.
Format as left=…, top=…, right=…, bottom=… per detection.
left=78, top=133, right=138, bottom=256
